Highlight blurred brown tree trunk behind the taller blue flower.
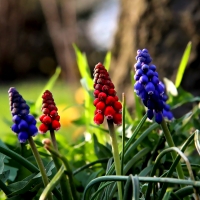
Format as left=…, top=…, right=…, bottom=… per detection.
left=111, top=0, right=200, bottom=105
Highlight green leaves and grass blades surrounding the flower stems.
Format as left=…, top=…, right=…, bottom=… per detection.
left=0, top=43, right=200, bottom=200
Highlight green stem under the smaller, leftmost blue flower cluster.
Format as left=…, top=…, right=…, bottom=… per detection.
left=28, top=137, right=53, bottom=200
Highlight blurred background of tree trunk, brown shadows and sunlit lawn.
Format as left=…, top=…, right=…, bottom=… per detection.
left=0, top=0, right=200, bottom=142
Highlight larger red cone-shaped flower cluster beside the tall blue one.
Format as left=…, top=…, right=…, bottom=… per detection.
left=93, top=63, right=122, bottom=125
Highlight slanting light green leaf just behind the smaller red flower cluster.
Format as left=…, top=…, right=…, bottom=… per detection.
left=35, top=67, right=61, bottom=113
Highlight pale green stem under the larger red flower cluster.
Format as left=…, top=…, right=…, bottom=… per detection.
left=107, top=120, right=123, bottom=200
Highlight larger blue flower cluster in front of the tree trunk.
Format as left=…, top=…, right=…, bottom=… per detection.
left=134, top=49, right=173, bottom=124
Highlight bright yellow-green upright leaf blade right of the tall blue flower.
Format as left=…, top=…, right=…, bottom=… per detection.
left=175, top=42, right=192, bottom=88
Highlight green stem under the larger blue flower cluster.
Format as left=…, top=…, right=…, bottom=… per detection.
left=161, top=119, right=184, bottom=179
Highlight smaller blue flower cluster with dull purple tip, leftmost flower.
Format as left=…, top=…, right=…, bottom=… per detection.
left=8, top=87, right=38, bottom=143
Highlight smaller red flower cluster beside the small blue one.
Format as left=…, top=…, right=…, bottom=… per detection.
left=39, top=90, right=60, bottom=133
